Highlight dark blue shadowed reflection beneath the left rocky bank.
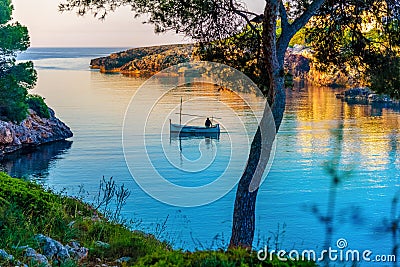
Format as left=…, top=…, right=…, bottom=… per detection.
left=0, top=141, right=72, bottom=179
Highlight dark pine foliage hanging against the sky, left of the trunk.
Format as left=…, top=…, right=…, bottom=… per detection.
left=59, top=0, right=246, bottom=41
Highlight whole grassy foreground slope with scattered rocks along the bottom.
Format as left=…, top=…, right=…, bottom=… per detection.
left=0, top=173, right=315, bottom=266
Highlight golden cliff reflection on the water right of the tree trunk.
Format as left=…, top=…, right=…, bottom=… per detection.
left=287, top=86, right=400, bottom=171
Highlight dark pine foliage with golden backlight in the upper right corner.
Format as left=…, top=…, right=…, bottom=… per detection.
left=307, top=0, right=400, bottom=97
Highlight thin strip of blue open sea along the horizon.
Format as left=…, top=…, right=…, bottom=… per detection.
left=17, top=47, right=127, bottom=60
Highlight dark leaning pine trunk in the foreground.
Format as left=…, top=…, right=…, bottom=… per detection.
left=229, top=0, right=286, bottom=248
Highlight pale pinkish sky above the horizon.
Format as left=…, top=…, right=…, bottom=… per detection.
left=12, top=0, right=265, bottom=47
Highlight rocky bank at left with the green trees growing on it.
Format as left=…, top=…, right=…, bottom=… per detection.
left=0, top=0, right=72, bottom=157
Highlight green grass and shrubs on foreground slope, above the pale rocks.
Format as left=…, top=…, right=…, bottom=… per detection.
left=0, top=173, right=169, bottom=266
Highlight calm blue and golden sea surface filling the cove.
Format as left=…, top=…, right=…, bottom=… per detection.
left=10, top=48, right=400, bottom=260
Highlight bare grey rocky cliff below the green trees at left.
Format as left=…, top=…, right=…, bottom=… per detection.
left=0, top=108, right=73, bottom=156
